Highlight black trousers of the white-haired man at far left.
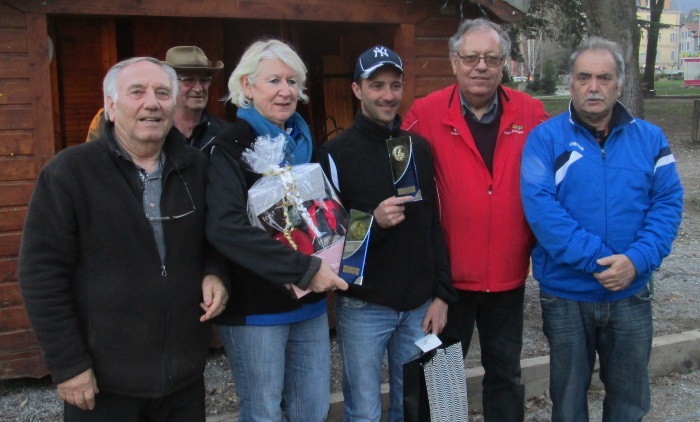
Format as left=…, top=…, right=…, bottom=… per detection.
left=63, top=377, right=206, bottom=422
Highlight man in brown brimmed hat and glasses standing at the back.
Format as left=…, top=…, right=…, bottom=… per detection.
left=164, top=46, right=228, bottom=150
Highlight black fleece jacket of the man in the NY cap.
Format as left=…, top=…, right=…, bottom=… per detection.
left=317, top=112, right=456, bottom=311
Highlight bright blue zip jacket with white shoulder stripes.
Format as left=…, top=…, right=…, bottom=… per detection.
left=520, top=103, right=683, bottom=302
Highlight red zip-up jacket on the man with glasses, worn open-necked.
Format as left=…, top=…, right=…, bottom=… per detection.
left=402, top=84, right=549, bottom=292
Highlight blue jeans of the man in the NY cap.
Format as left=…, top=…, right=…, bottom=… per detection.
left=335, top=296, right=430, bottom=422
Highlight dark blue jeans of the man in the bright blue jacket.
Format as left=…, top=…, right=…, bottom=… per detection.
left=540, top=288, right=654, bottom=422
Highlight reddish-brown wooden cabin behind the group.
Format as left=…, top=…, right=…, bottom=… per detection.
left=0, top=0, right=529, bottom=379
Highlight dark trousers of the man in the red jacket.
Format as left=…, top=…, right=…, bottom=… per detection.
left=441, top=286, right=525, bottom=422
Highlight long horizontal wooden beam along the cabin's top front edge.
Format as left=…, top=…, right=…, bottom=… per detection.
left=5, top=0, right=432, bottom=24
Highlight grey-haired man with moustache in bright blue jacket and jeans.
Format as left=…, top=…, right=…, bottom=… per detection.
left=521, top=38, right=683, bottom=422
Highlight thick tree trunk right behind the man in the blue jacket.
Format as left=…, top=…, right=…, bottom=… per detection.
left=583, top=0, right=644, bottom=118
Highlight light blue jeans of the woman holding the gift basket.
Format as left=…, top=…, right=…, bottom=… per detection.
left=219, top=313, right=331, bottom=422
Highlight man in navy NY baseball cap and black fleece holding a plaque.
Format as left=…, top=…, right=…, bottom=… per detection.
left=318, top=46, right=457, bottom=421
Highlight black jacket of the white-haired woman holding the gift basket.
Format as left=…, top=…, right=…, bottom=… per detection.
left=207, top=120, right=326, bottom=325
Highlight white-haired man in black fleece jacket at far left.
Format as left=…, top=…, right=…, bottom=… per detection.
left=19, top=57, right=228, bottom=421
